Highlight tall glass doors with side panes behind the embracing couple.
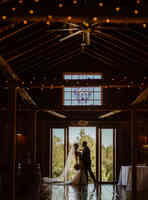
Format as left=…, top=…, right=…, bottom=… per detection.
left=49, top=127, right=116, bottom=183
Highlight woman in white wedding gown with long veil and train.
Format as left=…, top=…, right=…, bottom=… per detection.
left=43, top=143, right=87, bottom=185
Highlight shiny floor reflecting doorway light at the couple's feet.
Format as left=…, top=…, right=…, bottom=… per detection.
left=0, top=184, right=148, bottom=200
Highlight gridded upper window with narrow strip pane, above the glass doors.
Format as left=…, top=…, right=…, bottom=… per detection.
left=64, top=73, right=102, bottom=106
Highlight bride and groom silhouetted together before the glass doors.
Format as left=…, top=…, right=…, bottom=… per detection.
left=43, top=141, right=96, bottom=188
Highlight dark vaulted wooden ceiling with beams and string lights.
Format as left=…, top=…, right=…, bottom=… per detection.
left=0, top=0, right=148, bottom=120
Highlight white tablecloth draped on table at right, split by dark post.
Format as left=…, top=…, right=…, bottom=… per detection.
left=118, top=166, right=148, bottom=191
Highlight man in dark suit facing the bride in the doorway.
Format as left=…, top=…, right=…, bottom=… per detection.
left=81, top=141, right=97, bottom=184
